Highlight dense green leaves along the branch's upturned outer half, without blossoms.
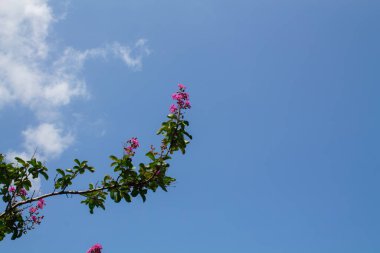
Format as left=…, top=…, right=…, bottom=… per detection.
left=82, top=108, right=192, bottom=213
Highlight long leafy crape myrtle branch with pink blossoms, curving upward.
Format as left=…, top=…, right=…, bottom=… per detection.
left=0, top=84, right=192, bottom=240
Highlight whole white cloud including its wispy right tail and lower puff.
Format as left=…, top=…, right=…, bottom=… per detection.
left=0, top=0, right=150, bottom=165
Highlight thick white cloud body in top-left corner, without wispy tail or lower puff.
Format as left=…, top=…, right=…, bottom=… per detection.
left=0, top=0, right=87, bottom=116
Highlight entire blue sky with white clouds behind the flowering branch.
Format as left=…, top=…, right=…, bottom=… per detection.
left=0, top=0, right=380, bottom=253
